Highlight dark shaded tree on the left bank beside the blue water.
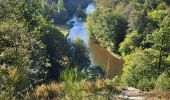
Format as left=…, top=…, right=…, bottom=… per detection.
left=42, top=26, right=72, bottom=80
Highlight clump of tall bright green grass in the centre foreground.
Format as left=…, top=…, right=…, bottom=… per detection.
left=60, top=68, right=86, bottom=99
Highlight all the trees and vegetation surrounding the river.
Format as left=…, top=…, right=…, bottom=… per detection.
left=0, top=0, right=170, bottom=100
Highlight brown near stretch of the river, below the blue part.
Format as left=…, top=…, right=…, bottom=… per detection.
left=88, top=40, right=124, bottom=78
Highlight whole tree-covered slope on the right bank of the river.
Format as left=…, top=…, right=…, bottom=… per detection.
left=87, top=0, right=170, bottom=91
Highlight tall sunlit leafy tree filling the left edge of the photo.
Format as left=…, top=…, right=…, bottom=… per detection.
left=0, top=0, right=65, bottom=96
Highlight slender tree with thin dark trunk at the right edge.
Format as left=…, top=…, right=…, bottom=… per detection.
left=150, top=16, right=170, bottom=70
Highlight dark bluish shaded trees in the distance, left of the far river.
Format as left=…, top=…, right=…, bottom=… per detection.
left=52, top=0, right=92, bottom=24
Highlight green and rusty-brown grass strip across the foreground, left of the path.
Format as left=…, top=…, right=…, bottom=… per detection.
left=34, top=67, right=122, bottom=100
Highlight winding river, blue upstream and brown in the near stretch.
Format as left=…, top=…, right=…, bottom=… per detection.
left=67, top=3, right=123, bottom=78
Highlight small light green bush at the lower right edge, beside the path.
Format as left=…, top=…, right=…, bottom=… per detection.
left=156, top=70, right=170, bottom=91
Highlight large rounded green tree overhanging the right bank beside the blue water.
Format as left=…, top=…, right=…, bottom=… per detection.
left=87, top=7, right=127, bottom=52
